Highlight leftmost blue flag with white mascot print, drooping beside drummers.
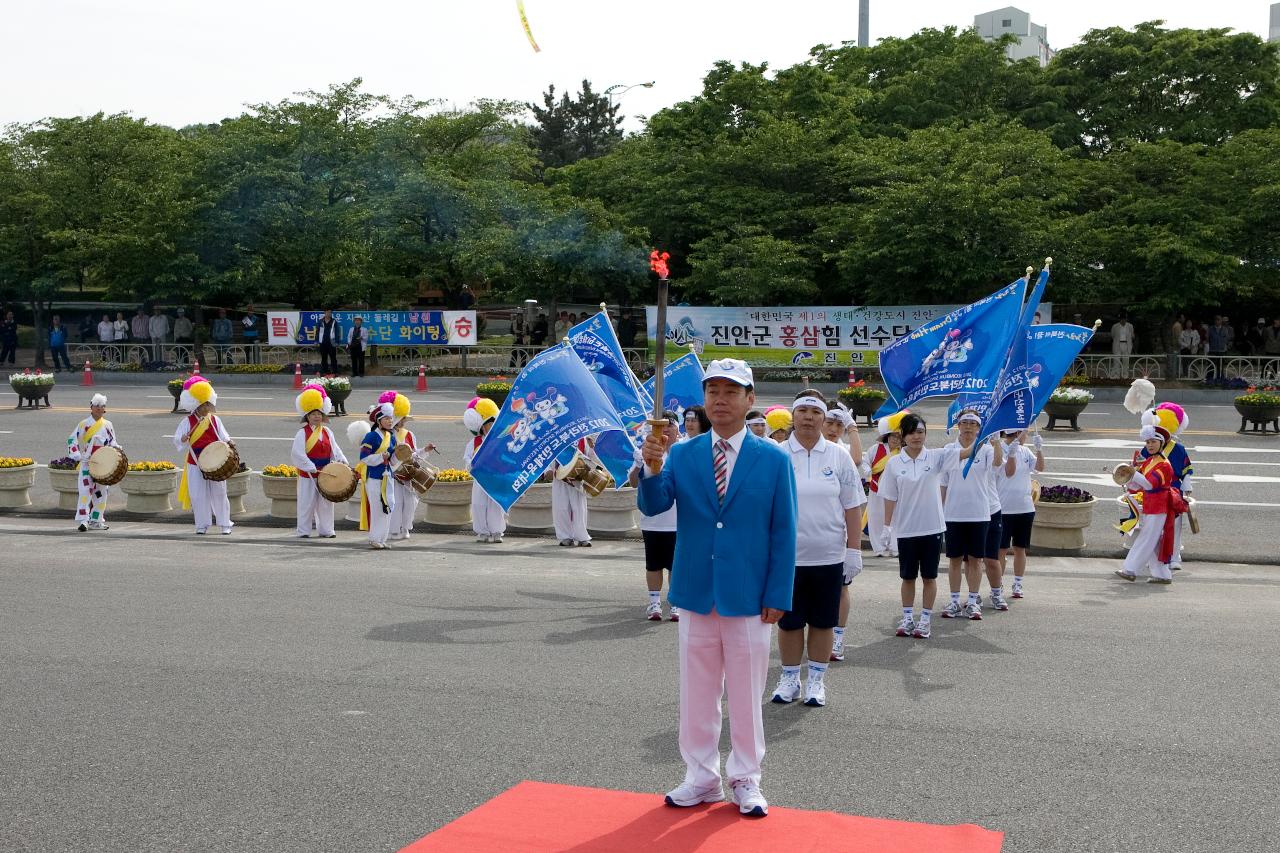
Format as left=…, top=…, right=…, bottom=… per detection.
left=471, top=346, right=632, bottom=510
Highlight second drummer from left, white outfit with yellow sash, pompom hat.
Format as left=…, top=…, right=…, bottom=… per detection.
left=173, top=377, right=236, bottom=535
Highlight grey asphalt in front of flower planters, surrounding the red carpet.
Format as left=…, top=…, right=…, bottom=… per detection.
left=0, top=517, right=1280, bottom=853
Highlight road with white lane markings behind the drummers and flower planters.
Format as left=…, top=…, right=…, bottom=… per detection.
left=0, top=378, right=1280, bottom=564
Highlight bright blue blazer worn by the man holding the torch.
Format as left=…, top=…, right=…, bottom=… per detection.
left=637, top=430, right=796, bottom=616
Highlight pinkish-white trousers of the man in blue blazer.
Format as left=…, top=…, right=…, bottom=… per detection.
left=680, top=610, right=772, bottom=788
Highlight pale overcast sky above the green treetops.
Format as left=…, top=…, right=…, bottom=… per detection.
left=0, top=0, right=1270, bottom=129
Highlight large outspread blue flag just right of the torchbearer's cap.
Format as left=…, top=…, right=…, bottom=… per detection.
left=876, top=278, right=1027, bottom=418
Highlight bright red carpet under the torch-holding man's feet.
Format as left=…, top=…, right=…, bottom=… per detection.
left=401, top=781, right=1004, bottom=853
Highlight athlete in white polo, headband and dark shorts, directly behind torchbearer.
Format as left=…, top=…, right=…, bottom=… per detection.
left=773, top=388, right=867, bottom=707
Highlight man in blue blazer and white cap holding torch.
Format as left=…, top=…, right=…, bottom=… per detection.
left=639, top=359, right=796, bottom=817
